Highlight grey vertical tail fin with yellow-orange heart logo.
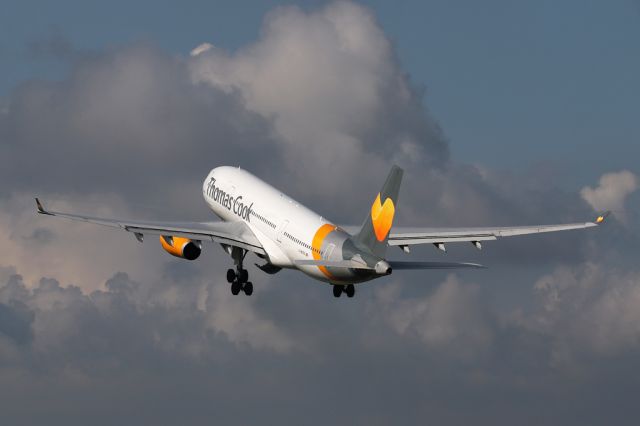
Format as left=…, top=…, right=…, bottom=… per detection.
left=354, top=165, right=403, bottom=257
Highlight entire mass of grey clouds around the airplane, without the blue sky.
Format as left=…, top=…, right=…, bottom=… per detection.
left=0, top=2, right=640, bottom=425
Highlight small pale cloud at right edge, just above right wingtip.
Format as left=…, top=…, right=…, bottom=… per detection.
left=580, top=170, right=638, bottom=218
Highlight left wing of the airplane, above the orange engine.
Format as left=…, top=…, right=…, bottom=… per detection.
left=36, top=198, right=266, bottom=255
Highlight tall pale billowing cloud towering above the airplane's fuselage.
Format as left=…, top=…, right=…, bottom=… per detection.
left=190, top=2, right=449, bottom=200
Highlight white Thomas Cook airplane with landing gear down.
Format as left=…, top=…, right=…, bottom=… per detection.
left=36, top=165, right=609, bottom=297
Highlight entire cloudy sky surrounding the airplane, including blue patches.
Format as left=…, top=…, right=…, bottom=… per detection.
left=0, top=0, right=640, bottom=425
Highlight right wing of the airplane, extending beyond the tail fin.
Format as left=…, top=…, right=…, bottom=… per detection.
left=388, top=212, right=609, bottom=249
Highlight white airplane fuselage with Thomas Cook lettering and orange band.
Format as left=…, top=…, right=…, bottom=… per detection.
left=202, top=166, right=363, bottom=283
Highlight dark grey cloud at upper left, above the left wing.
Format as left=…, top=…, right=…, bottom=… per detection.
left=0, top=45, right=279, bottom=210
